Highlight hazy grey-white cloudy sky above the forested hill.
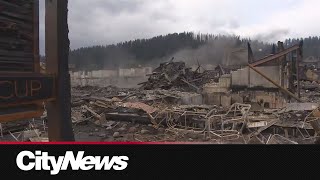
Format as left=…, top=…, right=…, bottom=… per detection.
left=40, top=0, right=320, bottom=54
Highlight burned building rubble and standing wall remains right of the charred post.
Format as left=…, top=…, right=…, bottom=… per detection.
left=2, top=42, right=320, bottom=144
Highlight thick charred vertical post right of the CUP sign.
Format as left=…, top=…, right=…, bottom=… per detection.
left=45, top=0, right=74, bottom=141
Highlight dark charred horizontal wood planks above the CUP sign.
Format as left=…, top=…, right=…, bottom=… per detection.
left=0, top=0, right=38, bottom=72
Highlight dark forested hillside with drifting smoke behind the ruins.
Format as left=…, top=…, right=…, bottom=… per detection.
left=70, top=32, right=320, bottom=70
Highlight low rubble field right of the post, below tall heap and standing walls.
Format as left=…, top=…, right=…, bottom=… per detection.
left=65, top=84, right=318, bottom=144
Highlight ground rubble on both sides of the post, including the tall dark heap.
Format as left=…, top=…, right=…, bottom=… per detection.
left=1, top=62, right=320, bottom=144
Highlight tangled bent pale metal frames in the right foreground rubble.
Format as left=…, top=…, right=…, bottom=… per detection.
left=149, top=103, right=320, bottom=144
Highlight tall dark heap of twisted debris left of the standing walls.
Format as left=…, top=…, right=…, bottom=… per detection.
left=140, top=61, right=216, bottom=91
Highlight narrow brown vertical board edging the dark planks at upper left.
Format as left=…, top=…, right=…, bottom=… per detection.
left=33, top=0, right=40, bottom=73
